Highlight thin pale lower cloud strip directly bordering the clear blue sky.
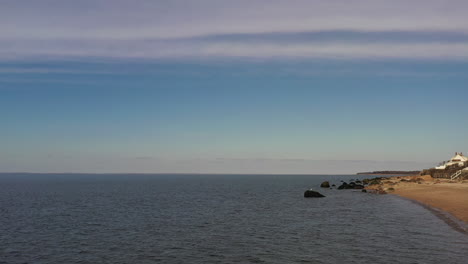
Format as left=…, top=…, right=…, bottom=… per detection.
left=0, top=36, right=468, bottom=60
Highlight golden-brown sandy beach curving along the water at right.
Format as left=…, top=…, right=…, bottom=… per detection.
left=366, top=175, right=468, bottom=224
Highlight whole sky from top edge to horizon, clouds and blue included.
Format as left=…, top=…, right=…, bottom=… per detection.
left=0, top=0, right=468, bottom=174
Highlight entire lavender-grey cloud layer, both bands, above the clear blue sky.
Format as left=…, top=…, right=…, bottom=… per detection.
left=0, top=0, right=468, bottom=60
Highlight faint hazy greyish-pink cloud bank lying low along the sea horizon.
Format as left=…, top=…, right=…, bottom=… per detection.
left=0, top=157, right=435, bottom=174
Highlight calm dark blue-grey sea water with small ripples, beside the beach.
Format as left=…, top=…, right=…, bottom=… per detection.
left=0, top=174, right=468, bottom=263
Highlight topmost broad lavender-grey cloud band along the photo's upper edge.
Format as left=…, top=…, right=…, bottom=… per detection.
left=0, top=0, right=468, bottom=39
